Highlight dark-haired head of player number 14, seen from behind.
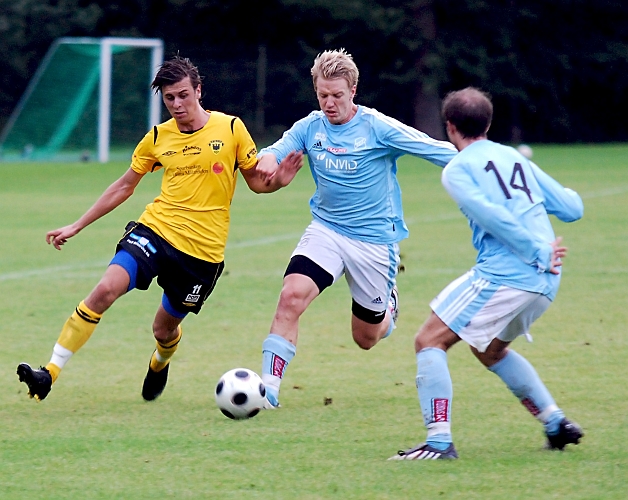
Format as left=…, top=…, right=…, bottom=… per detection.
left=442, top=87, right=493, bottom=138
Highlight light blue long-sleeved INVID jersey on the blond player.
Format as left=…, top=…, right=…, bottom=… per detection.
left=259, top=106, right=457, bottom=244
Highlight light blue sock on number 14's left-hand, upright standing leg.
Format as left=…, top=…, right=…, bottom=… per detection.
left=416, top=347, right=454, bottom=450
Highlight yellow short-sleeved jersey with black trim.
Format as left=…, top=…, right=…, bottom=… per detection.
left=131, top=111, right=257, bottom=262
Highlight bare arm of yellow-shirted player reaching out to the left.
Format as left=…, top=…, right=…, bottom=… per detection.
left=46, top=168, right=143, bottom=250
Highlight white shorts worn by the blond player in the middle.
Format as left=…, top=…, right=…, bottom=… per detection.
left=292, top=221, right=399, bottom=312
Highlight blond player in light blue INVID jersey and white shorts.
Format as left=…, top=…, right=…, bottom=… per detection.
left=258, top=50, right=457, bottom=407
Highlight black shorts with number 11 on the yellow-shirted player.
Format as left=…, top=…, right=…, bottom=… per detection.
left=116, top=221, right=225, bottom=314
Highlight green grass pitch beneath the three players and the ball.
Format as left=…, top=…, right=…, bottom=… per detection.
left=0, top=145, right=628, bottom=499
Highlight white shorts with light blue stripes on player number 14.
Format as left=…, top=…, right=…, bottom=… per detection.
left=430, top=269, right=551, bottom=352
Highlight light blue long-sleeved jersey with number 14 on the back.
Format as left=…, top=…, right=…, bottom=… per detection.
left=442, top=140, right=583, bottom=299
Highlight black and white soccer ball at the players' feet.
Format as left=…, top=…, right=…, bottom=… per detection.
left=216, top=368, right=266, bottom=420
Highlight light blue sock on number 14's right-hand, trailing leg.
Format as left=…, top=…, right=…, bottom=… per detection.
left=489, top=349, right=565, bottom=434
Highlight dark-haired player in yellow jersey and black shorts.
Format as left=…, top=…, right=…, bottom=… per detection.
left=17, top=56, right=303, bottom=401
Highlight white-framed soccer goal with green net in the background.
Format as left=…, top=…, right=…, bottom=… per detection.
left=0, top=37, right=163, bottom=162
